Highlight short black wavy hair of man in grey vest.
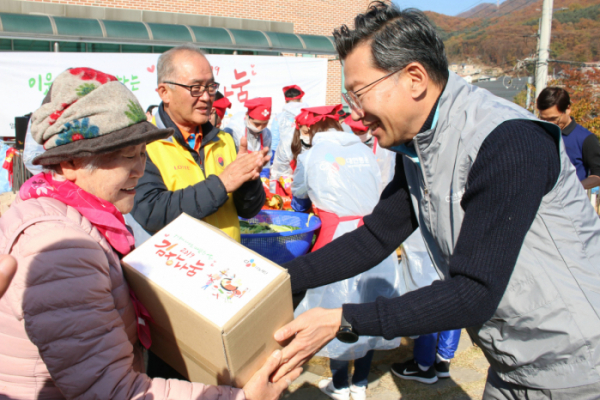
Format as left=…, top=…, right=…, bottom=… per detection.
left=333, top=1, right=449, bottom=87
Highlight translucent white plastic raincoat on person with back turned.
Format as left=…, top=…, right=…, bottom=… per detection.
left=292, top=131, right=406, bottom=361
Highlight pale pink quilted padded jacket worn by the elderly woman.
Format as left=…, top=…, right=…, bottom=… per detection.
left=0, top=196, right=245, bottom=400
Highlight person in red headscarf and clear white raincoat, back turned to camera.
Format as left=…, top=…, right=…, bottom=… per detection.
left=292, top=105, right=402, bottom=400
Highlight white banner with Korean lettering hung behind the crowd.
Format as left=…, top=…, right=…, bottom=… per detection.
left=0, top=52, right=327, bottom=136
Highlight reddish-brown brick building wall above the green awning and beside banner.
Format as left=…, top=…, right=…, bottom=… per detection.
left=33, top=0, right=371, bottom=104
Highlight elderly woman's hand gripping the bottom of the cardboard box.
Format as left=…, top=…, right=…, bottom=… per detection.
left=244, top=350, right=302, bottom=400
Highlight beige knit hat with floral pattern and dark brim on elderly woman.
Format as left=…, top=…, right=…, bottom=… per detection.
left=31, top=68, right=173, bottom=165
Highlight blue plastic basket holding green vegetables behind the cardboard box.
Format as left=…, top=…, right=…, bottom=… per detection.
left=240, top=210, right=321, bottom=265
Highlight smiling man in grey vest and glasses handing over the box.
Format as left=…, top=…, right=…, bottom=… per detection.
left=273, top=2, right=600, bottom=400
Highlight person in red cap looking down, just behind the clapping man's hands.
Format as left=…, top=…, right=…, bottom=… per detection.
left=224, top=97, right=271, bottom=153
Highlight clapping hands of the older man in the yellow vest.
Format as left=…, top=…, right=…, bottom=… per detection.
left=219, top=137, right=268, bottom=193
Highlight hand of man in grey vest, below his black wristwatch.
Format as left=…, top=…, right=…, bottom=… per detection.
left=273, top=307, right=342, bottom=382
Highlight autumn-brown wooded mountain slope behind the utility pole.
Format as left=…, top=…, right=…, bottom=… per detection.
left=426, top=0, right=600, bottom=68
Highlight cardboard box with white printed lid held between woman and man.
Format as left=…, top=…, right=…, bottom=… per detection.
left=122, top=214, right=294, bottom=387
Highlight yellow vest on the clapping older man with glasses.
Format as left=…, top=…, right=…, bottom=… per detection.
left=146, top=126, right=241, bottom=242
